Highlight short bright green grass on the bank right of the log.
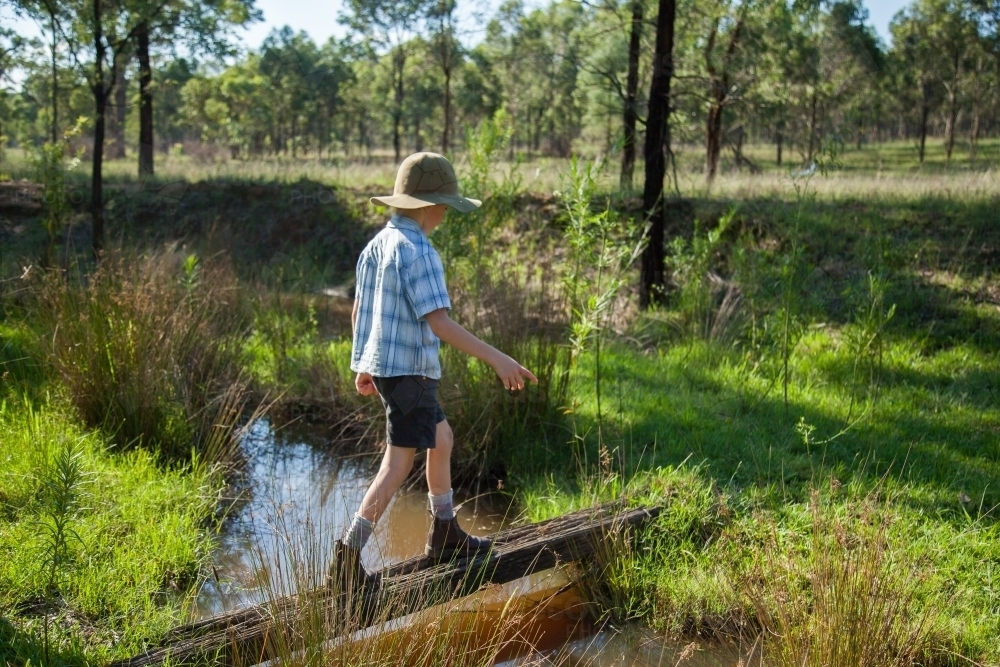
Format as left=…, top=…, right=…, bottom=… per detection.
left=514, top=249, right=1000, bottom=664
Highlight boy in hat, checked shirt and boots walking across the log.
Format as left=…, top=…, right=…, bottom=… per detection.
left=331, top=153, right=538, bottom=588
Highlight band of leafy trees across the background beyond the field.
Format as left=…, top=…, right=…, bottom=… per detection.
left=0, top=0, right=1000, bottom=180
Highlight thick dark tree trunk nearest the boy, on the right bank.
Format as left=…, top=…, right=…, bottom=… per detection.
left=639, top=0, right=677, bottom=308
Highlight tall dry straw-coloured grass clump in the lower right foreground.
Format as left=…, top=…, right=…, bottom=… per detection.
left=752, top=484, right=944, bottom=667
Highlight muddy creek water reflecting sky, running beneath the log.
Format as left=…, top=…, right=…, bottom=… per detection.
left=192, top=419, right=738, bottom=667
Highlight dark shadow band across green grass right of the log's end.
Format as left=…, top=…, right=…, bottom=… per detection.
left=541, top=348, right=1000, bottom=519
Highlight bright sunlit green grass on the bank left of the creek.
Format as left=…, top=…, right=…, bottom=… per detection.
left=0, top=323, right=220, bottom=665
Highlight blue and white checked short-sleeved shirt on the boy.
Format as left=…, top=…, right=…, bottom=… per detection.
left=351, top=215, right=451, bottom=380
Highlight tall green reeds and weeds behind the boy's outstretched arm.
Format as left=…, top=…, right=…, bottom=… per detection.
left=433, top=112, right=570, bottom=486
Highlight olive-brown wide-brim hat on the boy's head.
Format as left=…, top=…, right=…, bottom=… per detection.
left=371, top=152, right=483, bottom=213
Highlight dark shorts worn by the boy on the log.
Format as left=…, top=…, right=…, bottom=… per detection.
left=372, top=375, right=445, bottom=449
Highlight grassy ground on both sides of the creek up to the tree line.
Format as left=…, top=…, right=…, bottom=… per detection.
left=0, top=140, right=1000, bottom=665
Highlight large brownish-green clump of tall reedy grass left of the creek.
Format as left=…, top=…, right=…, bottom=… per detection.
left=33, top=247, right=256, bottom=460
